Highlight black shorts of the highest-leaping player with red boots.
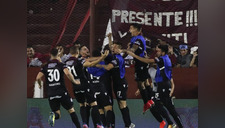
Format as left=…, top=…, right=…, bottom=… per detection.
left=135, top=65, right=150, bottom=82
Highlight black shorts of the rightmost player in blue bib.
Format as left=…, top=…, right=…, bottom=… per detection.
left=155, top=80, right=171, bottom=102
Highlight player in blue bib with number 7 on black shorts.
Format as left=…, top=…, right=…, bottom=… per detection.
left=96, top=43, right=135, bottom=128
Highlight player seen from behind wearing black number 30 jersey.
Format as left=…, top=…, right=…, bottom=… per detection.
left=36, top=48, right=81, bottom=128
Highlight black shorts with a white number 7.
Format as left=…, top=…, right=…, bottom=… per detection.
left=113, top=79, right=128, bottom=100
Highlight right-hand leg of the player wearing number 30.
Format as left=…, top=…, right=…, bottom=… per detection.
left=60, top=92, right=81, bottom=128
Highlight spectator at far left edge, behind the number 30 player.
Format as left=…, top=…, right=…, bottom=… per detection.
left=27, top=46, right=43, bottom=67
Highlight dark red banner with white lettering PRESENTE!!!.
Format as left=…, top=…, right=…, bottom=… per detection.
left=110, top=0, right=198, bottom=46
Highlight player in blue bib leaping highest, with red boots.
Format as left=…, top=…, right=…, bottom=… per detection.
left=127, top=23, right=154, bottom=113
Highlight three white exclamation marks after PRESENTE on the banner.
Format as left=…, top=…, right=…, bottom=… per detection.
left=186, top=10, right=198, bottom=27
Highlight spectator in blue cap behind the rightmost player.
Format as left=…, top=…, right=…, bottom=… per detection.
left=176, top=45, right=192, bottom=68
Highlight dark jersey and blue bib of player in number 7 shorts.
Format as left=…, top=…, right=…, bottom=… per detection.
left=110, top=54, right=125, bottom=85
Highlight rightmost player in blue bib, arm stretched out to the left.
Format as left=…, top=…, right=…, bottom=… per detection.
left=127, top=45, right=183, bottom=128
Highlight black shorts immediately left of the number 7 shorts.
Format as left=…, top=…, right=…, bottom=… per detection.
left=92, top=83, right=112, bottom=108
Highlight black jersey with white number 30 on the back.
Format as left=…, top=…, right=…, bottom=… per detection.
left=41, top=59, right=67, bottom=97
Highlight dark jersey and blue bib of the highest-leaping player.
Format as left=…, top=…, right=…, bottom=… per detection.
left=130, top=35, right=147, bottom=68
